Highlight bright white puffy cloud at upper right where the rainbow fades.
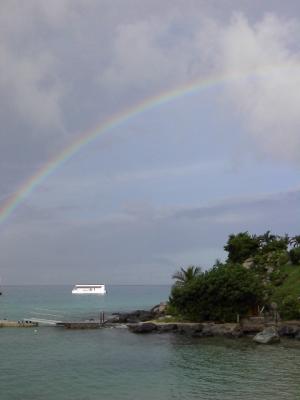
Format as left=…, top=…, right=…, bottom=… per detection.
left=214, top=14, right=300, bottom=162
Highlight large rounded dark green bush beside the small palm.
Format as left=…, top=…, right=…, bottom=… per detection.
left=170, top=265, right=264, bottom=321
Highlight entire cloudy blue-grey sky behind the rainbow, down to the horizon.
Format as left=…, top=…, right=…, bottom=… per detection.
left=0, top=0, right=300, bottom=284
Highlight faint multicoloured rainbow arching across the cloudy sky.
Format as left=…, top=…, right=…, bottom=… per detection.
left=0, top=65, right=286, bottom=224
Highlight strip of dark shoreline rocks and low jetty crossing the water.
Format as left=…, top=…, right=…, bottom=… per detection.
left=0, top=307, right=300, bottom=341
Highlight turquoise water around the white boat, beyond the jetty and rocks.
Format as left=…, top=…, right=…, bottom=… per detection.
left=0, top=285, right=170, bottom=320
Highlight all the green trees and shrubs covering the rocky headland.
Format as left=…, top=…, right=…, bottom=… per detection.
left=169, top=231, right=300, bottom=321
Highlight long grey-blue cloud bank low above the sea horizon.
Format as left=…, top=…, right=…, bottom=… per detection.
left=0, top=190, right=300, bottom=283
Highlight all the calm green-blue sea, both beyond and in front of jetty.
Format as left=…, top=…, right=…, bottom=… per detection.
left=0, top=286, right=300, bottom=400
